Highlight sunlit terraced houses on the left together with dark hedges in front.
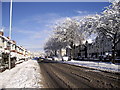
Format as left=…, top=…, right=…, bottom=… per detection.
left=0, top=30, right=31, bottom=71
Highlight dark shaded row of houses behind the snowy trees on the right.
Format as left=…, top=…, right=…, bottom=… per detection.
left=57, top=35, right=120, bottom=58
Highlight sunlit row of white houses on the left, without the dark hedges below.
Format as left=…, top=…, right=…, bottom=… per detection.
left=0, top=31, right=31, bottom=60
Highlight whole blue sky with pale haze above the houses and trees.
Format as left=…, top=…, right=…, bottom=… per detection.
left=2, top=2, right=110, bottom=51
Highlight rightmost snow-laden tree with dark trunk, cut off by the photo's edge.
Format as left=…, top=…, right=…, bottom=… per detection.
left=97, top=0, right=120, bottom=62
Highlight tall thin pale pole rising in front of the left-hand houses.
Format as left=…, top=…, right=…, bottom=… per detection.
left=9, top=0, right=12, bottom=69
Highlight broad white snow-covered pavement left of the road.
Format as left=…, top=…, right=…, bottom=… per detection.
left=0, top=60, right=43, bottom=88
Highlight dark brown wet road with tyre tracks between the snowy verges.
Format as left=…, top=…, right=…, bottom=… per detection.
left=39, top=60, right=120, bottom=88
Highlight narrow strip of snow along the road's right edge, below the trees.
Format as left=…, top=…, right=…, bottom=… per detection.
left=64, top=60, right=120, bottom=72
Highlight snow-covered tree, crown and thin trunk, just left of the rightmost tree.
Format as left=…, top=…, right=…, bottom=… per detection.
left=74, top=14, right=100, bottom=58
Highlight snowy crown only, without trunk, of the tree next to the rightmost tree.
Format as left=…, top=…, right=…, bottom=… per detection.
left=80, top=14, right=101, bottom=40
